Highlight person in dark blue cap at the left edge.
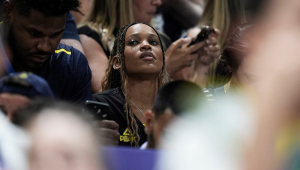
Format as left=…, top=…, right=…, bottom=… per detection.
left=0, top=72, right=54, bottom=120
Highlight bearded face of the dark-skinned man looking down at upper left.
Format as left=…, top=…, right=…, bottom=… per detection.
left=3, top=2, right=67, bottom=71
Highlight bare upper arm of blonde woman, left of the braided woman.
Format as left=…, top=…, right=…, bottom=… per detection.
left=79, top=34, right=108, bottom=93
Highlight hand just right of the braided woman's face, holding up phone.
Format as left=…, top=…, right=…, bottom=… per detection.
left=165, top=38, right=205, bottom=77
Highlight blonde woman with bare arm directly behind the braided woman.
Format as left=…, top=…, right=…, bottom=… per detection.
left=78, top=0, right=166, bottom=93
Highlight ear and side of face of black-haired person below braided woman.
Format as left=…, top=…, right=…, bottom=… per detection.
left=146, top=108, right=174, bottom=148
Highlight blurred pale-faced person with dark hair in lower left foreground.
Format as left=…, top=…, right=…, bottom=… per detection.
left=15, top=101, right=103, bottom=170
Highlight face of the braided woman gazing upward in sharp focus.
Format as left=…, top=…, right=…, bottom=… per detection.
left=124, top=24, right=163, bottom=75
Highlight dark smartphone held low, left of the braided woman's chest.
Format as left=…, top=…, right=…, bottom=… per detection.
left=83, top=100, right=109, bottom=120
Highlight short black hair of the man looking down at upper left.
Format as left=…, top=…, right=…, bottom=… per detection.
left=10, top=0, right=82, bottom=16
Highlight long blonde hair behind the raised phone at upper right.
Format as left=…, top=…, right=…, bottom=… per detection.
left=198, top=0, right=246, bottom=87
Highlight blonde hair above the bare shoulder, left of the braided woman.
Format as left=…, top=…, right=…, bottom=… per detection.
left=78, top=0, right=134, bottom=51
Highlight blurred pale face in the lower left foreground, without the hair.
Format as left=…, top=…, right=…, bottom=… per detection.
left=27, top=110, right=100, bottom=170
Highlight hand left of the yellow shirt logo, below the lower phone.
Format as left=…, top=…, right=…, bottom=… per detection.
left=96, top=120, right=120, bottom=145
